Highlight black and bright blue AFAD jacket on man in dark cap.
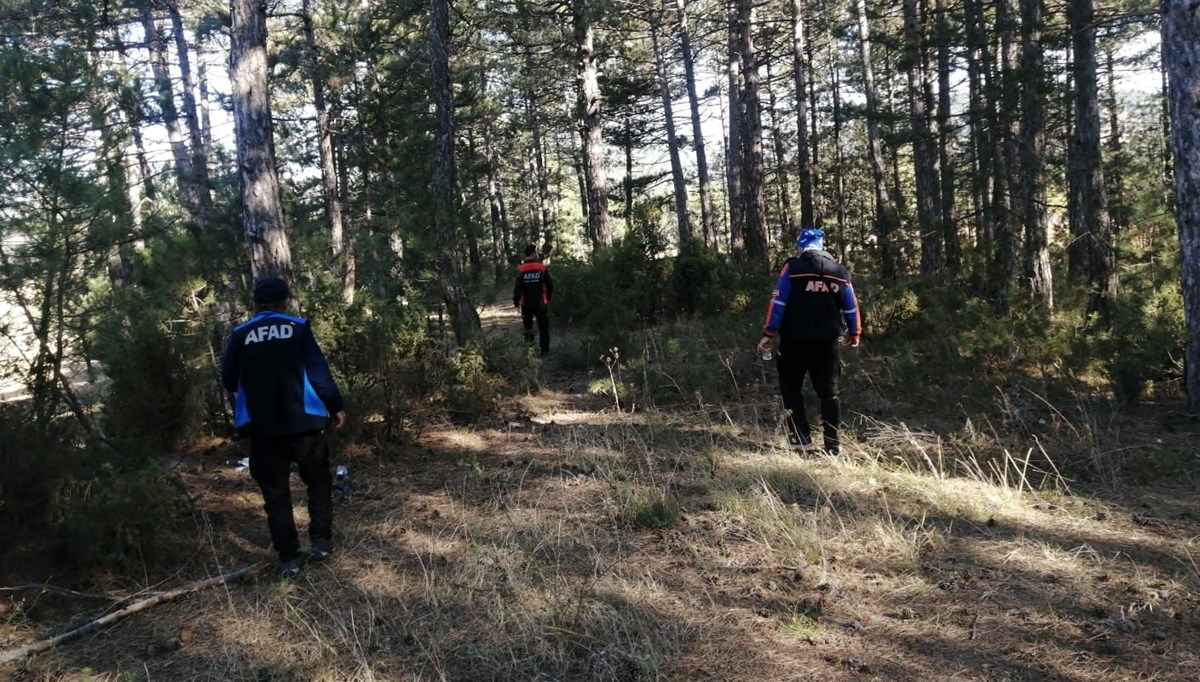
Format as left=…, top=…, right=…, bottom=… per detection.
left=221, top=310, right=343, bottom=438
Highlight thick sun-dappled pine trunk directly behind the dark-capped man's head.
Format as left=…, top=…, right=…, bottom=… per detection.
left=229, top=0, right=292, bottom=279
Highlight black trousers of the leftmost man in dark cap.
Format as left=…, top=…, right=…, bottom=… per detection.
left=250, top=431, right=334, bottom=561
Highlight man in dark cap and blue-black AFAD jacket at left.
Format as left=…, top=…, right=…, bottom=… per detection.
left=221, top=277, right=346, bottom=576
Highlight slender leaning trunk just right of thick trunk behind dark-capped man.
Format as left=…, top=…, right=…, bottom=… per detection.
left=300, top=0, right=356, bottom=305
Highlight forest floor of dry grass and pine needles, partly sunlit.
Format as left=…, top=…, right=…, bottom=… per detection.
left=0, top=294, right=1200, bottom=682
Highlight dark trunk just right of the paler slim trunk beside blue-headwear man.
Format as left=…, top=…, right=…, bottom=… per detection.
left=904, top=0, right=942, bottom=276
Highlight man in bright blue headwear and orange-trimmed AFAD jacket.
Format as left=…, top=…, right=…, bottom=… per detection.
left=758, top=229, right=863, bottom=455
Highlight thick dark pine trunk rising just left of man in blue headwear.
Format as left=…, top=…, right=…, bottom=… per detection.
left=737, top=0, right=767, bottom=265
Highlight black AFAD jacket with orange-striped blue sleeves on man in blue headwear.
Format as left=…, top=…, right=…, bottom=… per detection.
left=763, top=249, right=863, bottom=340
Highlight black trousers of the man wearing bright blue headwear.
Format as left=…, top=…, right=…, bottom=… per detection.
left=778, top=339, right=841, bottom=450
